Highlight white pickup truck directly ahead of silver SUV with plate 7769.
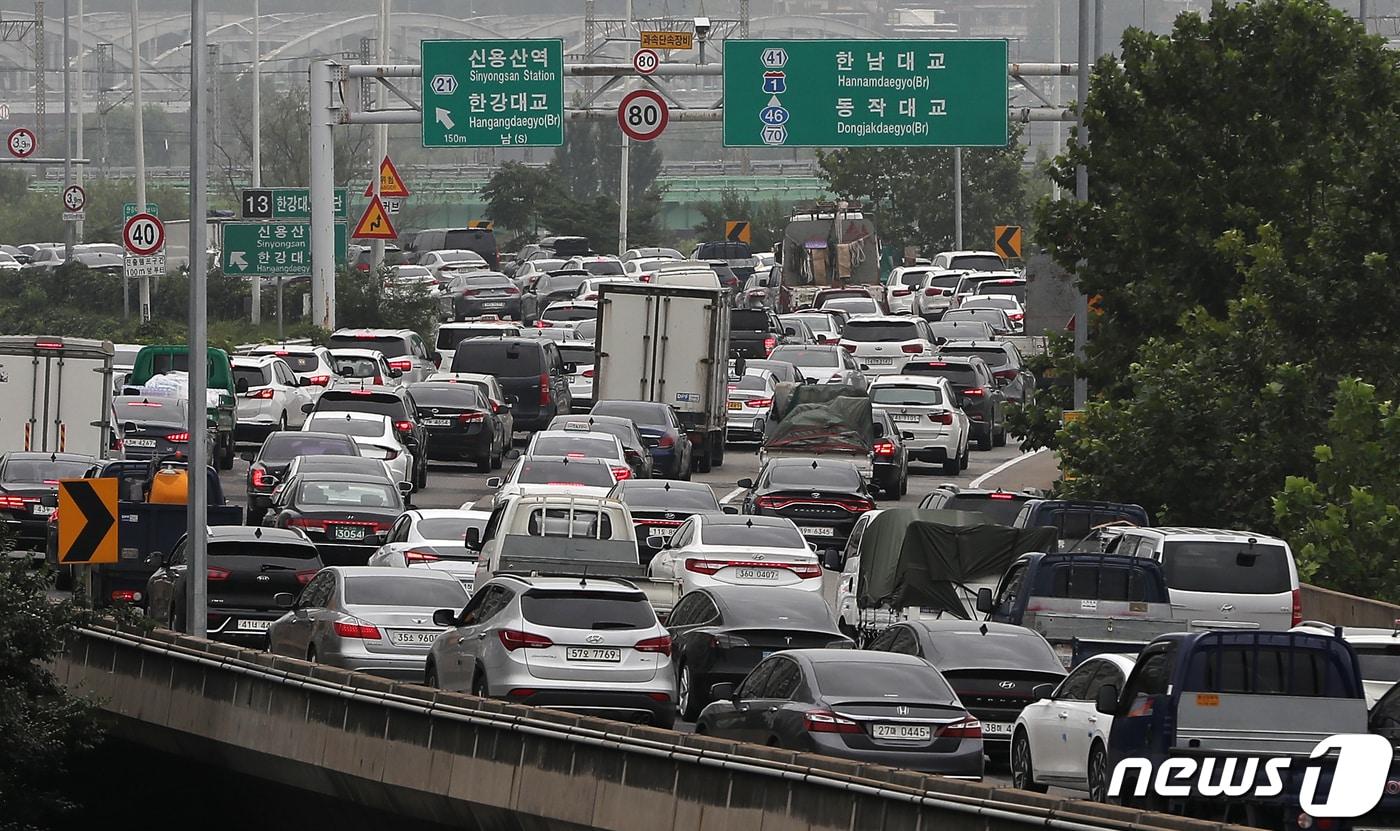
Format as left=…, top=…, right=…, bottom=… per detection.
left=466, top=494, right=680, bottom=621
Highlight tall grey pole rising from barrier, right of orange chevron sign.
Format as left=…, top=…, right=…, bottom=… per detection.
left=186, top=0, right=211, bottom=638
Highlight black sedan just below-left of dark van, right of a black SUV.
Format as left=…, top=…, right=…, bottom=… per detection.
left=409, top=381, right=510, bottom=473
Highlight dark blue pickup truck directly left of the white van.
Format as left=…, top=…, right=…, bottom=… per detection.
left=977, top=553, right=1190, bottom=669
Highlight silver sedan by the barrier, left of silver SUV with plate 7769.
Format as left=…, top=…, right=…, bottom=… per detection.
left=267, top=567, right=468, bottom=681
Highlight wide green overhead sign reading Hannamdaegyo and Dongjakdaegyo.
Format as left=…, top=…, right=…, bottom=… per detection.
left=722, top=39, right=1008, bottom=147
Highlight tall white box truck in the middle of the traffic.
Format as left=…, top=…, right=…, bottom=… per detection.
left=594, top=283, right=729, bottom=473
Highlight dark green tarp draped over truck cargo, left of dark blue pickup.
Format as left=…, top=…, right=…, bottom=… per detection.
left=857, top=508, right=1057, bottom=620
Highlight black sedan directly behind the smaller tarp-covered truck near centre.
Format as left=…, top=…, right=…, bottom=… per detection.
left=738, top=459, right=875, bottom=548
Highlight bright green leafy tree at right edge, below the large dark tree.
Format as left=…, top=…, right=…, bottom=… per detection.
left=1274, top=378, right=1400, bottom=603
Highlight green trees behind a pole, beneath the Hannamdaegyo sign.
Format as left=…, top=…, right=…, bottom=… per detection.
left=816, top=132, right=1029, bottom=256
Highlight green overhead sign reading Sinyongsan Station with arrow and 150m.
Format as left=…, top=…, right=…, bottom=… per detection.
left=421, top=39, right=562, bottom=147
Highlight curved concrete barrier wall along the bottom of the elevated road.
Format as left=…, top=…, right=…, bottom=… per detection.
left=55, top=628, right=1254, bottom=831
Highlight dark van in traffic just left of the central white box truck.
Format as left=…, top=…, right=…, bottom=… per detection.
left=452, top=337, right=577, bottom=431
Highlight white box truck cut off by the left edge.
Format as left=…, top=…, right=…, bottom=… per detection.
left=0, top=334, right=115, bottom=459
